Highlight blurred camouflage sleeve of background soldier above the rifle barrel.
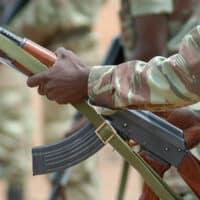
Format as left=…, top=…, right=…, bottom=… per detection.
left=7, top=0, right=103, bottom=45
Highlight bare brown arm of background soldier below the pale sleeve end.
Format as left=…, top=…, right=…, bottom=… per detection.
left=131, top=14, right=168, bottom=61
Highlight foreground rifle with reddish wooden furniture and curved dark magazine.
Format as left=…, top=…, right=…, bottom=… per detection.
left=0, top=28, right=200, bottom=200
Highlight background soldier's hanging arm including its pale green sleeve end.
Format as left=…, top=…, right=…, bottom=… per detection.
left=128, top=0, right=173, bottom=61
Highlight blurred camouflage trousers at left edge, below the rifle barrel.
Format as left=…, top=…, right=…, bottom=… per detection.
left=0, top=2, right=34, bottom=200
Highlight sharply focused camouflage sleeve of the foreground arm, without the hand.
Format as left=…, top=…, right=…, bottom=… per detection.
left=88, top=26, right=200, bottom=111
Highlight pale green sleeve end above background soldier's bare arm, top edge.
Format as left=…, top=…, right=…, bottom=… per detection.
left=130, top=0, right=174, bottom=16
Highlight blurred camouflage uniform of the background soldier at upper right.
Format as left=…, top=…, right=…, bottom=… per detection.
left=117, top=0, right=200, bottom=199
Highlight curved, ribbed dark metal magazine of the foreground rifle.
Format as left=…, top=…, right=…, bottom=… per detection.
left=32, top=124, right=104, bottom=175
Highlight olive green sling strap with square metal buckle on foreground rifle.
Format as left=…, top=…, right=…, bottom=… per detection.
left=0, top=35, right=181, bottom=200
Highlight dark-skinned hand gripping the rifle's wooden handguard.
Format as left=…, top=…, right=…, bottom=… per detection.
left=27, top=48, right=89, bottom=104
